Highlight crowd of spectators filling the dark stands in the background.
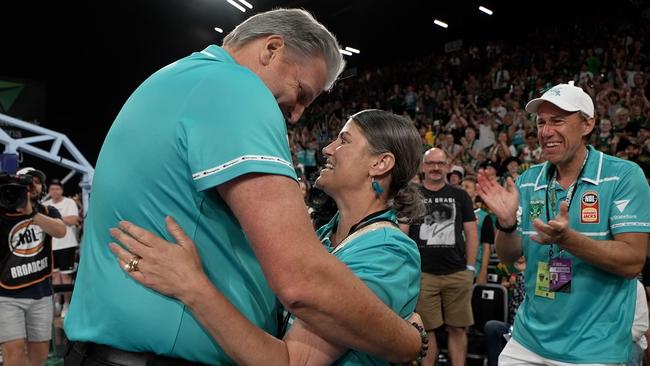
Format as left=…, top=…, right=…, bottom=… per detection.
left=289, top=17, right=650, bottom=197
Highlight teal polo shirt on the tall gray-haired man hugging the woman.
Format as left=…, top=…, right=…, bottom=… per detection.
left=65, top=46, right=296, bottom=364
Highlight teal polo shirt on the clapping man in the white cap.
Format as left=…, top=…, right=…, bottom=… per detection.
left=513, top=146, right=650, bottom=363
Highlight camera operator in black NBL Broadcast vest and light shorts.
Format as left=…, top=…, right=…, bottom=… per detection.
left=0, top=168, right=66, bottom=366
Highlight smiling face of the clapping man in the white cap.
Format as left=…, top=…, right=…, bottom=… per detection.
left=537, top=102, right=594, bottom=166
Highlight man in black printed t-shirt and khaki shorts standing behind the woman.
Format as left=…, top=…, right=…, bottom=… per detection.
left=402, top=148, right=478, bottom=365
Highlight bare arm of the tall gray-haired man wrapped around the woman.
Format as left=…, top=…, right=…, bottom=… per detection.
left=218, top=175, right=420, bottom=362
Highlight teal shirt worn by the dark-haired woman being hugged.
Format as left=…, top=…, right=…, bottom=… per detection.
left=317, top=210, right=420, bottom=366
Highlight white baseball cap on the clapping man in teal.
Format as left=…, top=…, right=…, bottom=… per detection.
left=526, top=81, right=594, bottom=118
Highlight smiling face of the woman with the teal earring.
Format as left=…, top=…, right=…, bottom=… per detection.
left=315, top=119, right=373, bottom=199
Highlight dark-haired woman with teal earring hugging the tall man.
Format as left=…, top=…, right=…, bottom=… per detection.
left=111, top=110, right=426, bottom=365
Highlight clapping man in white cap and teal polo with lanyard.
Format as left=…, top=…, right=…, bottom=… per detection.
left=479, top=84, right=650, bottom=366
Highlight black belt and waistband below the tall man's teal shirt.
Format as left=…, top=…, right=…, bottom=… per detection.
left=65, top=342, right=209, bottom=366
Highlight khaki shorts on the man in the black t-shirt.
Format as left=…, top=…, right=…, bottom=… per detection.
left=415, top=271, right=474, bottom=331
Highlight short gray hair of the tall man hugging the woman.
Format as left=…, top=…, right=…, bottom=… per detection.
left=223, top=9, right=345, bottom=90
